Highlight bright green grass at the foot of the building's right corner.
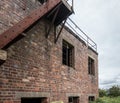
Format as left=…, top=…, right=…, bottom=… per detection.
left=90, top=97, right=120, bottom=103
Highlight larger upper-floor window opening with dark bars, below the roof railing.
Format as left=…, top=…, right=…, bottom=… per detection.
left=62, top=40, right=74, bottom=67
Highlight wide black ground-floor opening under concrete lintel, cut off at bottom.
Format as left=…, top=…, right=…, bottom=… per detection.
left=21, top=97, right=48, bottom=103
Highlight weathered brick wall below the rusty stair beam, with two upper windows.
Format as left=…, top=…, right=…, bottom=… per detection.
left=0, top=0, right=98, bottom=103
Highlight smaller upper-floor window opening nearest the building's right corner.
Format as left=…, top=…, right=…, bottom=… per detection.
left=88, top=57, right=95, bottom=75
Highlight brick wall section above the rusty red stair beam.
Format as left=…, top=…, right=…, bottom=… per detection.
left=0, top=0, right=41, bottom=34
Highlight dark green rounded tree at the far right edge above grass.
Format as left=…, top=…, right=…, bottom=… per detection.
left=108, top=86, right=120, bottom=97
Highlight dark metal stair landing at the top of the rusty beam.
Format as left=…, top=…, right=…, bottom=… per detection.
left=46, top=0, right=74, bottom=26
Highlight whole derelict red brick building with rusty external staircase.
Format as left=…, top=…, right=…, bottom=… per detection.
left=0, top=0, right=98, bottom=103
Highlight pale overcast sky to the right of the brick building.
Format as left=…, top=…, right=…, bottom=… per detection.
left=71, top=0, right=120, bottom=88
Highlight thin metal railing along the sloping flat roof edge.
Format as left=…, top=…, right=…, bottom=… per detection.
left=66, top=18, right=97, bottom=52
